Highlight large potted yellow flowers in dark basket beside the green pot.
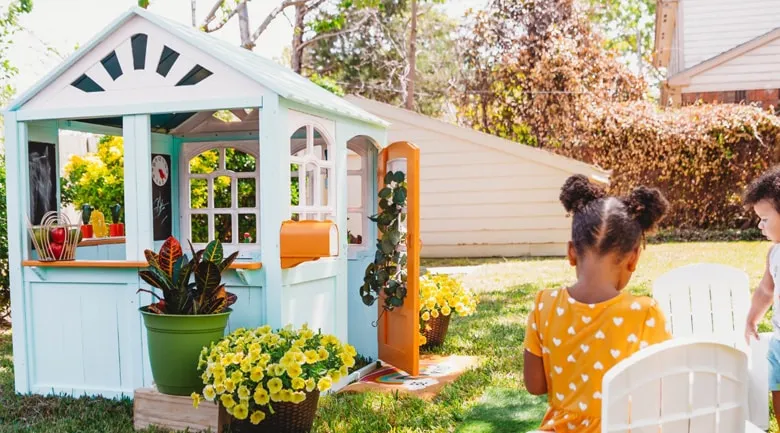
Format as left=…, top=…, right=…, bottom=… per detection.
left=192, top=324, right=357, bottom=433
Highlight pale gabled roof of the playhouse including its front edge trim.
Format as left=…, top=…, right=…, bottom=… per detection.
left=7, top=6, right=388, bottom=127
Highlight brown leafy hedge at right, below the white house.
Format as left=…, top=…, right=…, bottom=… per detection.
left=559, top=102, right=780, bottom=229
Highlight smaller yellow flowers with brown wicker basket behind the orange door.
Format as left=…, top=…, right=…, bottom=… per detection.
left=420, top=274, right=478, bottom=347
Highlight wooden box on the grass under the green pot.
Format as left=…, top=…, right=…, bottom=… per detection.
left=133, top=388, right=227, bottom=433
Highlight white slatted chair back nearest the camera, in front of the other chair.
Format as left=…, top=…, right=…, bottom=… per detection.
left=530, top=338, right=761, bottom=433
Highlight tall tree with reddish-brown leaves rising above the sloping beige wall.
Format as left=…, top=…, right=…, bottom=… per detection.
left=458, top=0, right=646, bottom=148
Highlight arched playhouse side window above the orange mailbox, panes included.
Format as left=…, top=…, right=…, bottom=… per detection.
left=290, top=125, right=336, bottom=221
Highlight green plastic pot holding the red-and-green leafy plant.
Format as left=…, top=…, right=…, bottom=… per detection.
left=139, top=307, right=233, bottom=395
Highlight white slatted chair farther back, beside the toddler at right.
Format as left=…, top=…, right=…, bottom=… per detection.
left=653, top=263, right=771, bottom=430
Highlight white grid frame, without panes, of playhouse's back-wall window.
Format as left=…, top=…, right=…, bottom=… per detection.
left=179, top=140, right=261, bottom=257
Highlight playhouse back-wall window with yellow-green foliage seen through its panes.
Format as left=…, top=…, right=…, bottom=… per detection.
left=181, top=142, right=260, bottom=251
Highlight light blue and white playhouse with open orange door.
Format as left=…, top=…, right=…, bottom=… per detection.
left=5, top=8, right=419, bottom=397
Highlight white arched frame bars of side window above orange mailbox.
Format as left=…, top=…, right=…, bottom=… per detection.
left=290, top=122, right=338, bottom=223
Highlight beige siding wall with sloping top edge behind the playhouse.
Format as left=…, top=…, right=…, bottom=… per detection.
left=350, top=98, right=603, bottom=257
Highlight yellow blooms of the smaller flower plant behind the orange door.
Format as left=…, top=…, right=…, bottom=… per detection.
left=420, top=274, right=479, bottom=346
